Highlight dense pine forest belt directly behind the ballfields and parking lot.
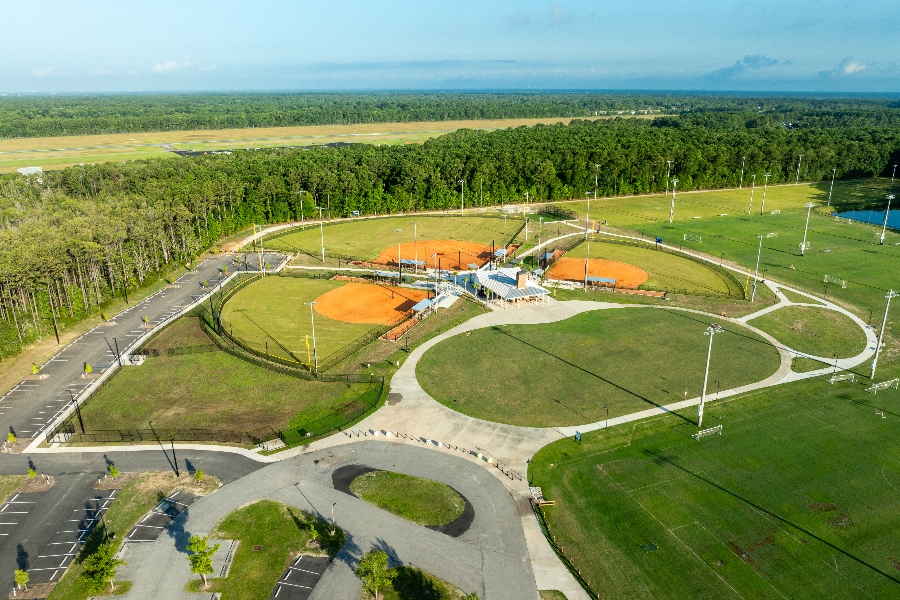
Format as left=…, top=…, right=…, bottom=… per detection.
left=0, top=102, right=900, bottom=357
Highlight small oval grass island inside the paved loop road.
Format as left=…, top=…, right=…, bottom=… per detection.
left=350, top=471, right=465, bottom=525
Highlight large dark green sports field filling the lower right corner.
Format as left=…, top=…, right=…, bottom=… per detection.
left=530, top=378, right=900, bottom=600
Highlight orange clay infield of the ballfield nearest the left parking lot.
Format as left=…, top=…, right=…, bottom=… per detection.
left=315, top=283, right=428, bottom=325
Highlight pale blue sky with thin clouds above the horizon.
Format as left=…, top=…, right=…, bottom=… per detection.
left=0, top=0, right=900, bottom=94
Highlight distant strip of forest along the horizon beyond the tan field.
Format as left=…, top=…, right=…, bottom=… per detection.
left=0, top=92, right=900, bottom=138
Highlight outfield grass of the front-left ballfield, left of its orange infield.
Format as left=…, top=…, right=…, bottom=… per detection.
left=222, top=277, right=381, bottom=364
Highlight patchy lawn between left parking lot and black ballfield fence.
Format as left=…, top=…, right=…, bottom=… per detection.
left=81, top=316, right=365, bottom=431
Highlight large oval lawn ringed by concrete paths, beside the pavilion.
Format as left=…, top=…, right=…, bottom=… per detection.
left=416, top=307, right=780, bottom=427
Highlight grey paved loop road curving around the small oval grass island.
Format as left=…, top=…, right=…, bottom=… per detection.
left=116, top=442, right=537, bottom=600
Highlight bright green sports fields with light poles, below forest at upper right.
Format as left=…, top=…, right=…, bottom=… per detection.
left=562, top=180, right=900, bottom=320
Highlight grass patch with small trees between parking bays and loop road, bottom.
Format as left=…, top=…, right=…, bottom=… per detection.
left=188, top=500, right=344, bottom=600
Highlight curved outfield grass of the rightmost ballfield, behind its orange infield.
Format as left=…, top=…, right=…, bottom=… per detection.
left=566, top=238, right=728, bottom=295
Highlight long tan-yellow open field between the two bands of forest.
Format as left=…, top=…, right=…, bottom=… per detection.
left=0, top=116, right=612, bottom=173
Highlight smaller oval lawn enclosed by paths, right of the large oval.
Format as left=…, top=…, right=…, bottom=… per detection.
left=747, top=306, right=866, bottom=358
